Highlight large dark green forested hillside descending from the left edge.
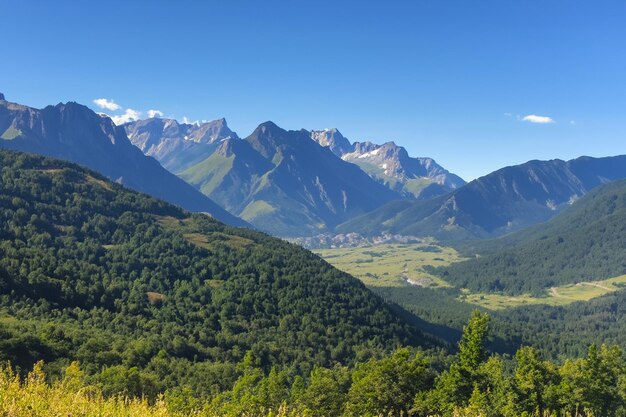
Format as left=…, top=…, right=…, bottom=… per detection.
left=0, top=150, right=424, bottom=395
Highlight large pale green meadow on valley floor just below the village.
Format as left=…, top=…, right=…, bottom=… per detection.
left=315, top=242, right=463, bottom=287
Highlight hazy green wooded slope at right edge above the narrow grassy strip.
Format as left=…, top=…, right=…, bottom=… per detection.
left=432, top=180, right=626, bottom=295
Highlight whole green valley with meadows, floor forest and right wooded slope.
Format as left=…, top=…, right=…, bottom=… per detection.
left=320, top=181, right=626, bottom=358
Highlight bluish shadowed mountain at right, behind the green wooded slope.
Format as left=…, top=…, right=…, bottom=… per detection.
left=338, top=156, right=626, bottom=240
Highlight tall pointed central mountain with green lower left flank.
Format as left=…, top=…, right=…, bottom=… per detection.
left=180, top=122, right=399, bottom=236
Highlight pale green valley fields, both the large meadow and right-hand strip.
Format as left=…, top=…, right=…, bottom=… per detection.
left=315, top=242, right=626, bottom=310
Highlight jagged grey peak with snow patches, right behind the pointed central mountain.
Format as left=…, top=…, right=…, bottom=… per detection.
left=311, top=129, right=465, bottom=199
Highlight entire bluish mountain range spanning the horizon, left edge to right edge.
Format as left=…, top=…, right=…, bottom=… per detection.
left=7, top=96, right=626, bottom=241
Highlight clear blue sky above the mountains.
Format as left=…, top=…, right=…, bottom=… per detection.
left=0, top=0, right=626, bottom=179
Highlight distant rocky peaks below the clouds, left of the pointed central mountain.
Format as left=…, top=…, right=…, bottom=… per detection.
left=123, top=118, right=238, bottom=173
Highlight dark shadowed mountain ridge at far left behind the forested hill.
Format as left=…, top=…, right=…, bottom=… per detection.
left=0, top=95, right=249, bottom=226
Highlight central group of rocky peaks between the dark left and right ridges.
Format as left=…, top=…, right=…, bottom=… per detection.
left=124, top=118, right=464, bottom=236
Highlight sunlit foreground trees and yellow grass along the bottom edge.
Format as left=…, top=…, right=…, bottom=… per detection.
left=0, top=312, right=626, bottom=417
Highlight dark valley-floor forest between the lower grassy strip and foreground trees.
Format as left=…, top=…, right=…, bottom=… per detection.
left=372, top=287, right=626, bottom=361
